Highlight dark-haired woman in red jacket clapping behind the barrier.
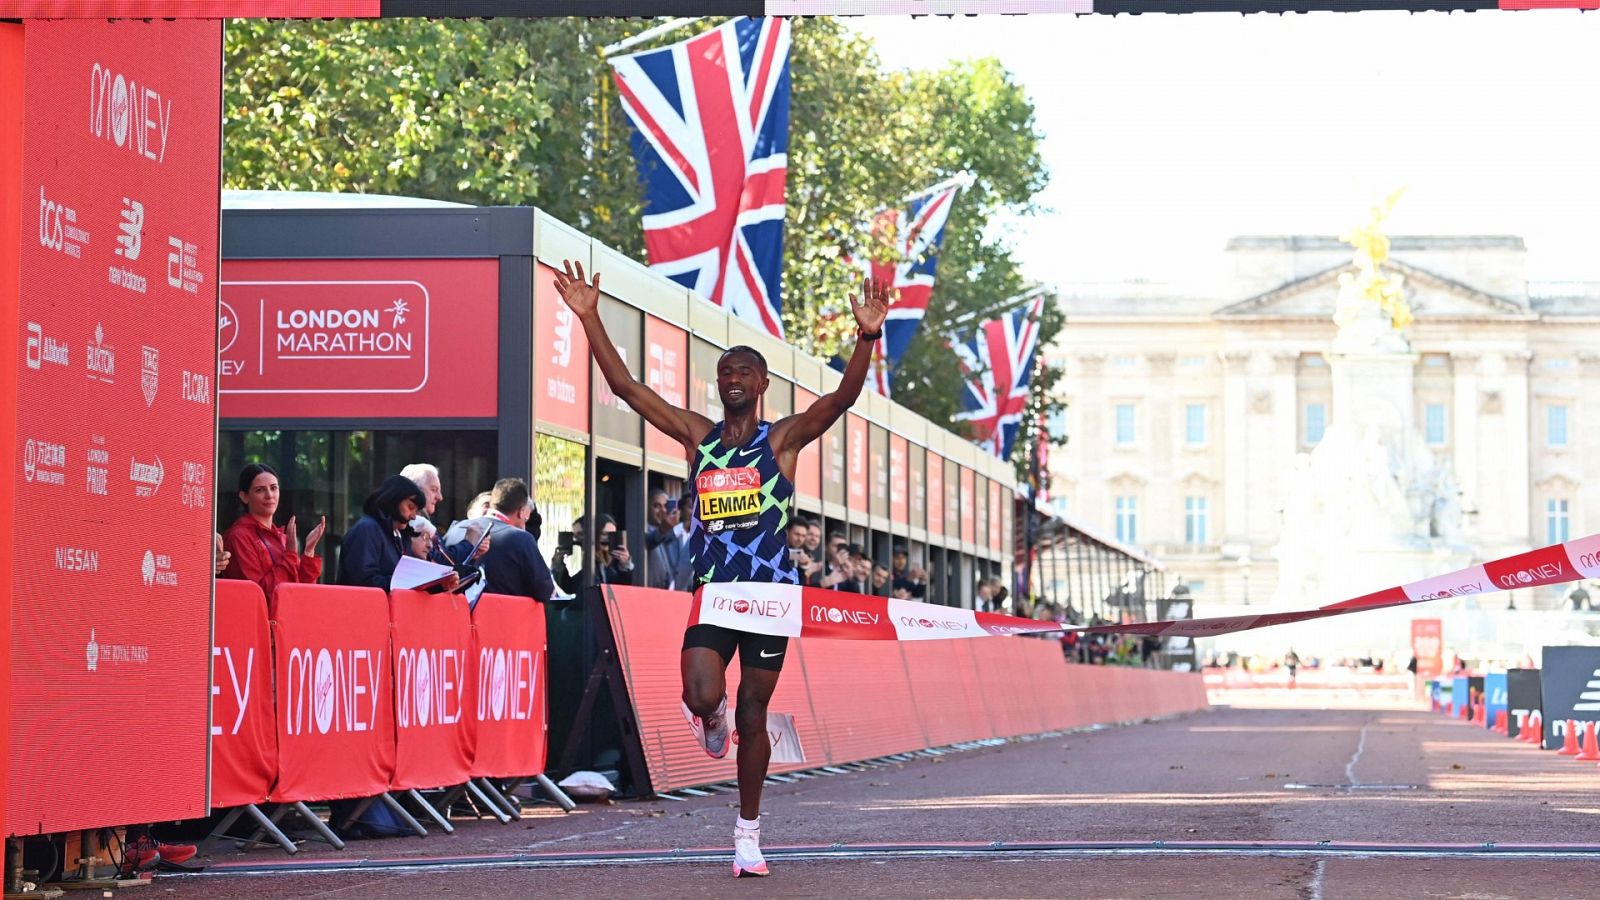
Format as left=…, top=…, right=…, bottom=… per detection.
left=222, top=463, right=328, bottom=599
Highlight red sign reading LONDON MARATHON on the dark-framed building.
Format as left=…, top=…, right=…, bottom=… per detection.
left=218, top=259, right=499, bottom=418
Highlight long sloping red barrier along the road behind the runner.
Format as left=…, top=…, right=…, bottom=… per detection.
left=606, top=588, right=1206, bottom=791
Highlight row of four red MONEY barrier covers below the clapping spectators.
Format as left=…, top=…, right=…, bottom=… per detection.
left=211, top=580, right=547, bottom=845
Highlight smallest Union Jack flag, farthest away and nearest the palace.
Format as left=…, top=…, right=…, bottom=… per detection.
left=952, top=295, right=1045, bottom=460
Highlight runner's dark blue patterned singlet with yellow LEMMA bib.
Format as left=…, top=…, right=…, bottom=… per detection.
left=690, top=423, right=800, bottom=585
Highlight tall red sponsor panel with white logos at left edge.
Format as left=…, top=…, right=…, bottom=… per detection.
left=5, top=19, right=222, bottom=833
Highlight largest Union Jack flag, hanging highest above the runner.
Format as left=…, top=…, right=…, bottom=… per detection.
left=611, top=19, right=789, bottom=338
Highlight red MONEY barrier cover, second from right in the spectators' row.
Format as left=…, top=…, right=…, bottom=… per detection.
left=389, top=591, right=472, bottom=791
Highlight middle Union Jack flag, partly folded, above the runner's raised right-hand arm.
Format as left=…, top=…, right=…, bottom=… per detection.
left=862, top=184, right=962, bottom=397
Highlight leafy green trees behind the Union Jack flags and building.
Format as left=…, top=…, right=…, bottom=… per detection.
left=224, top=18, right=1054, bottom=448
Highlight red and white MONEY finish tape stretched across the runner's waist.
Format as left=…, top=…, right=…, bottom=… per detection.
left=690, top=535, right=1600, bottom=641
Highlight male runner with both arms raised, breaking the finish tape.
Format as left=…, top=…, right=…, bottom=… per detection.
left=555, top=261, right=890, bottom=876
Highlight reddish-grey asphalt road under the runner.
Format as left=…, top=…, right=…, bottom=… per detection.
left=154, top=692, right=1600, bottom=900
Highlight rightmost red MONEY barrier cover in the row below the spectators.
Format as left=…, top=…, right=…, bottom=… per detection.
left=466, top=594, right=549, bottom=778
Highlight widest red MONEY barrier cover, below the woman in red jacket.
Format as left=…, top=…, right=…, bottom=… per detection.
left=270, top=585, right=395, bottom=802
